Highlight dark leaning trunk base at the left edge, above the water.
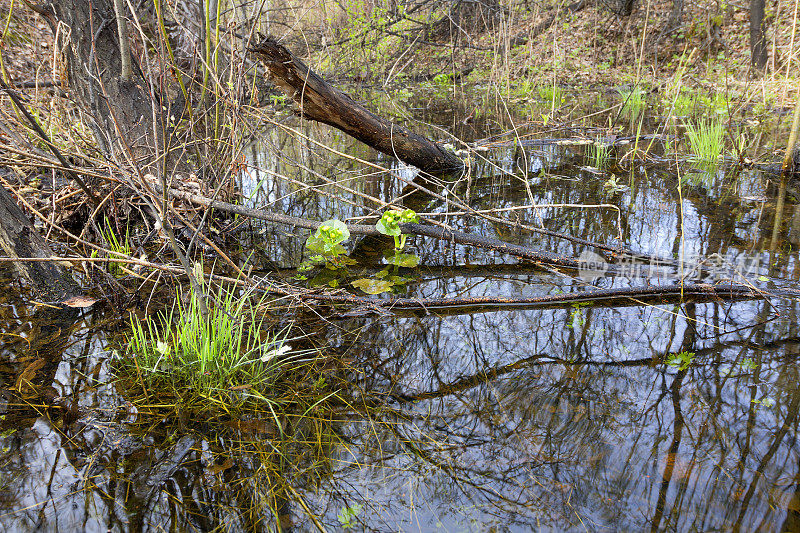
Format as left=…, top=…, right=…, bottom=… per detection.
left=0, top=186, right=82, bottom=302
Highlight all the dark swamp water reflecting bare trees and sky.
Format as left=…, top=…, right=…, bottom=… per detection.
left=0, top=85, right=800, bottom=531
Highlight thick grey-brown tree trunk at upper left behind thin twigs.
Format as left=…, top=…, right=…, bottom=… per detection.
left=43, top=0, right=208, bottom=316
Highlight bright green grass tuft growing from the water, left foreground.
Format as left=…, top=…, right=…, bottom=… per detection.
left=125, top=282, right=303, bottom=411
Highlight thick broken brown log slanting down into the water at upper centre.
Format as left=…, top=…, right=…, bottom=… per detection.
left=251, top=37, right=464, bottom=174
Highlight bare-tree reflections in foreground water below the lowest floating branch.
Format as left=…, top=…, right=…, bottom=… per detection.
left=0, top=294, right=800, bottom=530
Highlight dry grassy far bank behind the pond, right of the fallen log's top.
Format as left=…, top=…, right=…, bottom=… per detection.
left=300, top=0, right=798, bottom=107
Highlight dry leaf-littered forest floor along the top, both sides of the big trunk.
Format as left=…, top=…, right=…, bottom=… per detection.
left=0, top=0, right=798, bottom=164
